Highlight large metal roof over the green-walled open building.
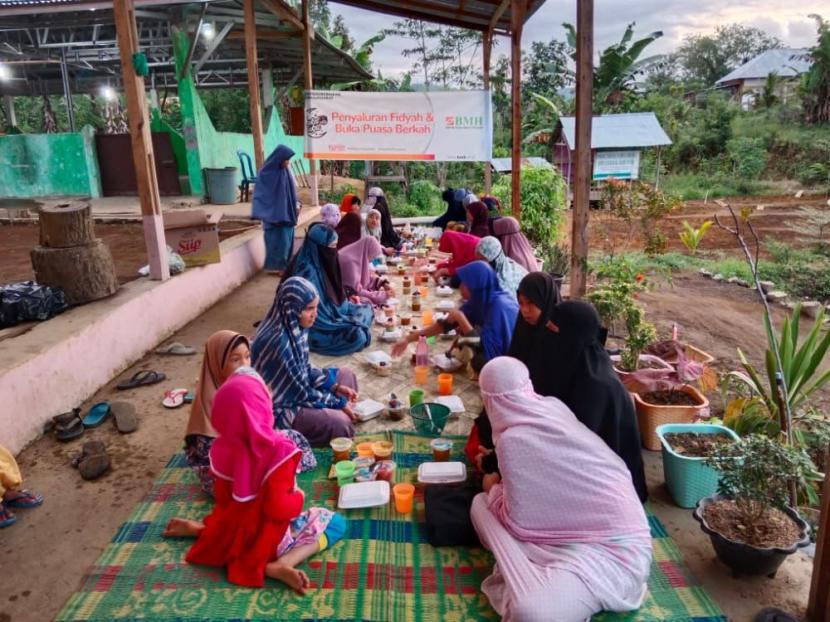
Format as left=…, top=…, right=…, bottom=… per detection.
left=0, top=0, right=371, bottom=95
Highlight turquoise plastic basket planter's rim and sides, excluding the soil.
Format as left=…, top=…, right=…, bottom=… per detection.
left=657, top=423, right=738, bottom=508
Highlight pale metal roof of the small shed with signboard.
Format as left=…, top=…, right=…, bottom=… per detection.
left=559, top=112, right=671, bottom=150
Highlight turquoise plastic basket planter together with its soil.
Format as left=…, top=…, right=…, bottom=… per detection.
left=657, top=423, right=740, bottom=508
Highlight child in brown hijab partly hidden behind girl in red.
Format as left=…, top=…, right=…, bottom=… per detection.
left=184, top=330, right=317, bottom=496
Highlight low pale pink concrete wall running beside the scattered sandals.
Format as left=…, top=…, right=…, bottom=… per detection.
left=0, top=230, right=265, bottom=453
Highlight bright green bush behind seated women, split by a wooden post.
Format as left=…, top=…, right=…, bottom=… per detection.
left=493, top=166, right=567, bottom=249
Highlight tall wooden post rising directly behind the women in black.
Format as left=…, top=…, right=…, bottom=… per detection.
left=571, top=0, right=594, bottom=298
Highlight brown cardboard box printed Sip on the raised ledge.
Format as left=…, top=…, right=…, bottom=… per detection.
left=163, top=209, right=222, bottom=268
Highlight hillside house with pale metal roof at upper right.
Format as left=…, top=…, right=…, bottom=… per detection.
left=715, top=48, right=811, bottom=110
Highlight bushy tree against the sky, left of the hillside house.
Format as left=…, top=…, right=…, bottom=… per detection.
left=672, top=24, right=783, bottom=87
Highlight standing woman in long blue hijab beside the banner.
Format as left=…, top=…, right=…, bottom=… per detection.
left=251, top=145, right=299, bottom=274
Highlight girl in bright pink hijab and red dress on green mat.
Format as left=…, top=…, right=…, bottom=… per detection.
left=164, top=374, right=346, bottom=594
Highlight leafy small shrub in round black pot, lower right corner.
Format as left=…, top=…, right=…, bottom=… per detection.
left=694, top=434, right=820, bottom=578
